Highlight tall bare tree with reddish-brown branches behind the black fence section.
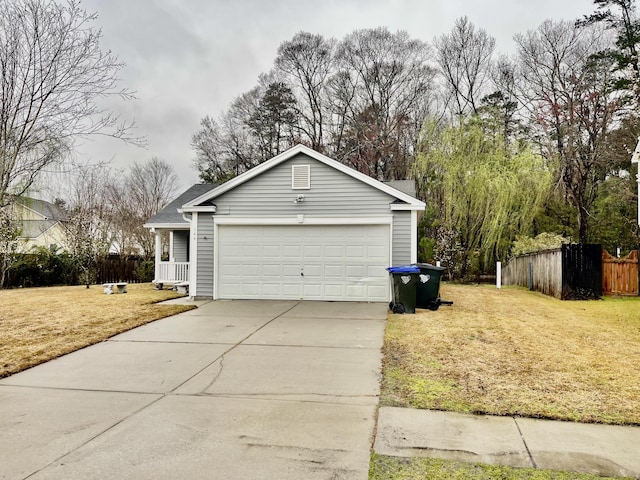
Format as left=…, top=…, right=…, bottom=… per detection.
left=515, top=21, right=622, bottom=242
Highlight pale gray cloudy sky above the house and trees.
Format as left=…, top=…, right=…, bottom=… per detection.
left=74, top=0, right=594, bottom=189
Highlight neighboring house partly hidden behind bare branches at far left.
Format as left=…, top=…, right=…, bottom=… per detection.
left=9, top=197, right=67, bottom=253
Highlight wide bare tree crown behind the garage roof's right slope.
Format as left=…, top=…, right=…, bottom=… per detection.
left=335, top=28, right=435, bottom=180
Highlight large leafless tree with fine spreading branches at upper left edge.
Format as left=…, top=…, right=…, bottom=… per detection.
left=0, top=0, right=140, bottom=206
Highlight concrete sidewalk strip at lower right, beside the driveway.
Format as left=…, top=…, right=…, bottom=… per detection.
left=374, top=407, right=640, bottom=479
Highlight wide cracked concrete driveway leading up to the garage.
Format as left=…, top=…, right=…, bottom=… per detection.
left=0, top=301, right=387, bottom=480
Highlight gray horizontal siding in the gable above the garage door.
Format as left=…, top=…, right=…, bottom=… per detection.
left=213, top=154, right=395, bottom=217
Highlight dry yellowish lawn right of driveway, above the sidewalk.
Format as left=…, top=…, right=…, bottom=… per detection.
left=382, top=284, right=640, bottom=425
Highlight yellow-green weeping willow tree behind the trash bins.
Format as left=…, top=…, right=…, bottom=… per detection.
left=414, top=121, right=551, bottom=277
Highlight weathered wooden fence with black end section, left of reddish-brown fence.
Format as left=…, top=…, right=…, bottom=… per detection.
left=502, top=244, right=602, bottom=300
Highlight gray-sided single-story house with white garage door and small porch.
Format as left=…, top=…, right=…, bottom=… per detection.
left=145, top=145, right=425, bottom=302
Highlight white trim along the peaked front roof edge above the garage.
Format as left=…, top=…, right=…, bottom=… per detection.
left=181, top=145, right=425, bottom=212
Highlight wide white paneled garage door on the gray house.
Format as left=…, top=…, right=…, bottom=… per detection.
left=217, top=225, right=390, bottom=302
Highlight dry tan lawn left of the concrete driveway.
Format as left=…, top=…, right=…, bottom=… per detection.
left=0, top=284, right=193, bottom=378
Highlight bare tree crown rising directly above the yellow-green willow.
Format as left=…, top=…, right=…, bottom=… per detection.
left=434, top=17, right=496, bottom=116
